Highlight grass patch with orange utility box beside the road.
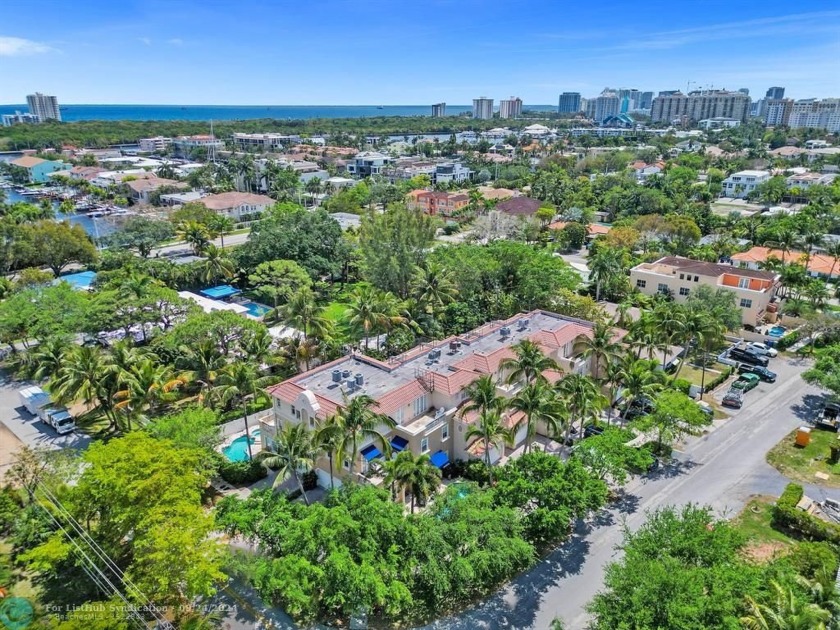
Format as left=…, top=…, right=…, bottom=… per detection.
left=767, top=429, right=840, bottom=488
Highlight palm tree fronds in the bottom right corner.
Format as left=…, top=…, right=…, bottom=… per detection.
left=741, top=580, right=831, bottom=630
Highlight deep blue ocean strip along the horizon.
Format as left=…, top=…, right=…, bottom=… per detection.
left=0, top=105, right=557, bottom=122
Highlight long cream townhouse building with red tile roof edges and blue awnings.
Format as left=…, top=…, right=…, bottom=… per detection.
left=270, top=311, right=593, bottom=487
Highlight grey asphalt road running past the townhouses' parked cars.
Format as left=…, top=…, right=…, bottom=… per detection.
left=428, top=358, right=828, bottom=630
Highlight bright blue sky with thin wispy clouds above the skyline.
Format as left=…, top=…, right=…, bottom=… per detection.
left=0, top=0, right=840, bottom=105
